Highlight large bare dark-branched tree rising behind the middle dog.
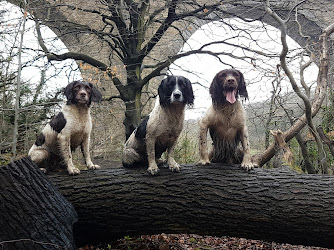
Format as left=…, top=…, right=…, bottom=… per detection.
left=10, top=0, right=286, bottom=137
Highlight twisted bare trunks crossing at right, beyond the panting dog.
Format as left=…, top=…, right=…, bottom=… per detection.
left=253, top=0, right=334, bottom=174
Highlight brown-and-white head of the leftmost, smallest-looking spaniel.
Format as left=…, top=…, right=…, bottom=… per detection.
left=64, top=81, right=102, bottom=106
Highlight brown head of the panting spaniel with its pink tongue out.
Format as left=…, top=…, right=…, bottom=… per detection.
left=210, top=69, right=248, bottom=105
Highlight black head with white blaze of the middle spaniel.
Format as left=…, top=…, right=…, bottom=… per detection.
left=158, top=76, right=194, bottom=107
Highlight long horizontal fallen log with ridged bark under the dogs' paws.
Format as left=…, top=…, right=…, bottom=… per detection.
left=3, top=158, right=334, bottom=247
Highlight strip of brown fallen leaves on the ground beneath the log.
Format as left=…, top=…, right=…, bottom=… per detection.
left=78, top=234, right=329, bottom=250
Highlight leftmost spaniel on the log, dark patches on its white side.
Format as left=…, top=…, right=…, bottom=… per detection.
left=28, top=81, right=102, bottom=175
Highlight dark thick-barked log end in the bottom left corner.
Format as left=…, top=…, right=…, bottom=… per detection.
left=0, top=158, right=77, bottom=250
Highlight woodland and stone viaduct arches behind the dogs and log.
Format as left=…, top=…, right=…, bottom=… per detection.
left=0, top=0, right=334, bottom=174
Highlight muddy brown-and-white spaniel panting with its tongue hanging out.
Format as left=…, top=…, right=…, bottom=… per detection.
left=199, top=69, right=254, bottom=170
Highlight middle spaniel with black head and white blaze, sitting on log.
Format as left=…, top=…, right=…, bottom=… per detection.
left=122, top=76, right=194, bottom=175
